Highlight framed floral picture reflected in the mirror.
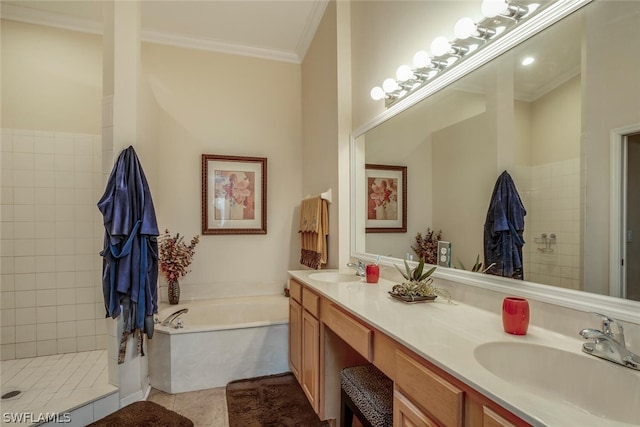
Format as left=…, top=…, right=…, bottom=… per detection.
left=365, top=164, right=407, bottom=233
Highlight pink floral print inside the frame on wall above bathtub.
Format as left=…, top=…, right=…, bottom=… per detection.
left=215, top=170, right=255, bottom=220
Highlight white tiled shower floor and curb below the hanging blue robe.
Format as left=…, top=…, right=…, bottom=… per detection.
left=0, top=350, right=120, bottom=426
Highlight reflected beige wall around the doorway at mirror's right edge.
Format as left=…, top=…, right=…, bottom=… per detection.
left=582, top=1, right=640, bottom=292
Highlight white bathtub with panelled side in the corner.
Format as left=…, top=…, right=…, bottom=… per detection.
left=148, top=295, right=289, bottom=393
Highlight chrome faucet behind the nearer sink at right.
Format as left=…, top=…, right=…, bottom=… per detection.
left=580, top=313, right=640, bottom=370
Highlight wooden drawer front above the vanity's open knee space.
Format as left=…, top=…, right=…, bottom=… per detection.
left=322, top=301, right=373, bottom=362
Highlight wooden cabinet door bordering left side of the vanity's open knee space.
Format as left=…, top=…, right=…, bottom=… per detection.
left=300, top=310, right=320, bottom=413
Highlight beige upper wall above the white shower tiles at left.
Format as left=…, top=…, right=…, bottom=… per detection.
left=1, top=20, right=102, bottom=134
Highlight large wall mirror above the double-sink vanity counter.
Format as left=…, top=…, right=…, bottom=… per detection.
left=352, top=0, right=640, bottom=314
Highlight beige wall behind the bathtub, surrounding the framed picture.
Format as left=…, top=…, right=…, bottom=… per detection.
left=142, top=44, right=302, bottom=298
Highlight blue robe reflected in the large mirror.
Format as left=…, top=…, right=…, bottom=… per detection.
left=484, top=171, right=527, bottom=280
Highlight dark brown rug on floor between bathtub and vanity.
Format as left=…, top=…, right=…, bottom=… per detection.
left=227, top=373, right=329, bottom=427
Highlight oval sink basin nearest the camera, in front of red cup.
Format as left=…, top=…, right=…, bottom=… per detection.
left=474, top=342, right=640, bottom=424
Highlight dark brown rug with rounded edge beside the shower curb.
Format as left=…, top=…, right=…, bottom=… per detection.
left=89, top=400, right=193, bottom=427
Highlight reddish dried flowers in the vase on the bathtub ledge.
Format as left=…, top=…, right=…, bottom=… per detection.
left=158, top=229, right=200, bottom=283
